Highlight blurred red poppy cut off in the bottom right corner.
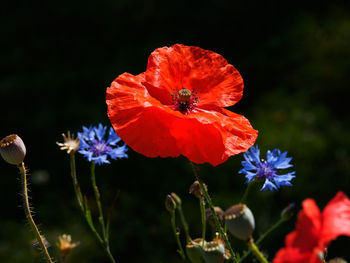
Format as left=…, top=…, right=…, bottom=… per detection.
left=273, top=192, right=350, bottom=263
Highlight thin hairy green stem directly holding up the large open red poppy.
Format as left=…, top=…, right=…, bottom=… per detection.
left=191, top=162, right=237, bottom=263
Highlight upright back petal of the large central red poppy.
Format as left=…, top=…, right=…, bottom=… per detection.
left=145, top=44, right=243, bottom=107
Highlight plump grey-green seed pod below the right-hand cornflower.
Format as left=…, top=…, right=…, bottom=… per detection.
left=224, top=204, right=255, bottom=240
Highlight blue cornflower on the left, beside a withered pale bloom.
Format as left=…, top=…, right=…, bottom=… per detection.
left=78, top=123, right=128, bottom=165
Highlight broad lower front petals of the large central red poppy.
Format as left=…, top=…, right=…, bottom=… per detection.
left=106, top=73, right=257, bottom=165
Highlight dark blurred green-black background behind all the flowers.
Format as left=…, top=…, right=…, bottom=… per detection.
left=0, top=0, right=350, bottom=263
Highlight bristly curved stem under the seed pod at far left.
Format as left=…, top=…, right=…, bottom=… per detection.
left=18, top=162, right=52, bottom=263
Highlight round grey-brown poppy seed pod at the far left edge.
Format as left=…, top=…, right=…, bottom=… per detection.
left=0, top=134, right=26, bottom=165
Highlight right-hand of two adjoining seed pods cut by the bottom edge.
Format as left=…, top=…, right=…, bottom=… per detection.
left=202, top=238, right=231, bottom=263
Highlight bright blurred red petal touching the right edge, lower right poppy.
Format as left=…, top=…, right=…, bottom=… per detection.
left=321, top=192, right=350, bottom=247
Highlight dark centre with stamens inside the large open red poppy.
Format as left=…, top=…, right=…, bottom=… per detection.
left=171, top=87, right=198, bottom=114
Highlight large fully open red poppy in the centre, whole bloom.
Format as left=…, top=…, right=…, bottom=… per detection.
left=106, top=45, right=257, bottom=165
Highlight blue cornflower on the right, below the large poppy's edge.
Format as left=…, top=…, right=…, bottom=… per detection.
left=239, top=146, right=295, bottom=191
